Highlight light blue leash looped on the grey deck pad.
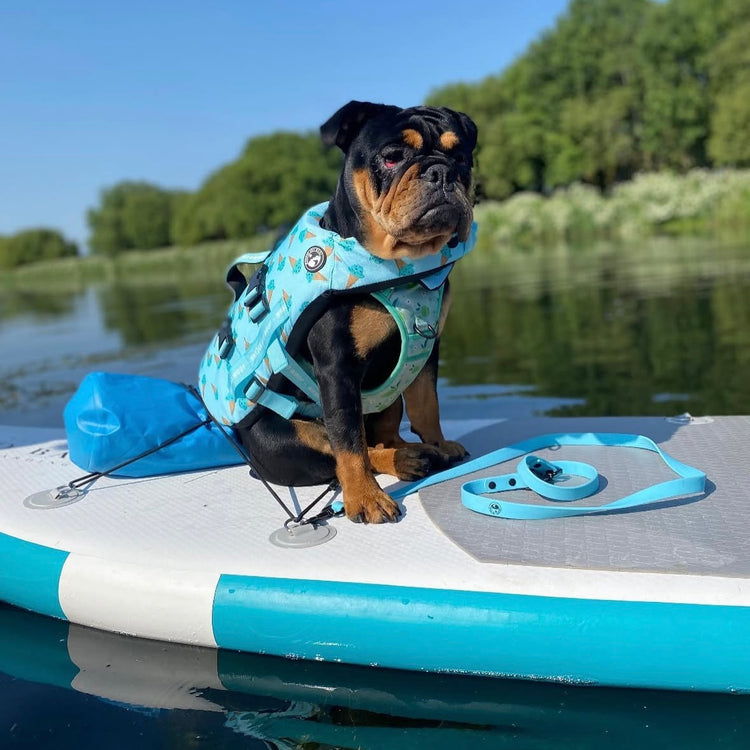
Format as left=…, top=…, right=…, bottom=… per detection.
left=390, top=432, right=706, bottom=520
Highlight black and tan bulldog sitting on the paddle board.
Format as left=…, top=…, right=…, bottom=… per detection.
left=238, top=101, right=477, bottom=523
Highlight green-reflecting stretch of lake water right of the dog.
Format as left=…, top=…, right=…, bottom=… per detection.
left=442, top=243, right=750, bottom=415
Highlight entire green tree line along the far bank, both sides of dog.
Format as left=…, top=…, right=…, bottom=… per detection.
left=0, top=0, right=750, bottom=266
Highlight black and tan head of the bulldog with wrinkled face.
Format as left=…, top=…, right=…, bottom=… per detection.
left=320, top=101, right=477, bottom=259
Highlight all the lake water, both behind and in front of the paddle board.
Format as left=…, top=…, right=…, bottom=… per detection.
left=0, top=240, right=750, bottom=750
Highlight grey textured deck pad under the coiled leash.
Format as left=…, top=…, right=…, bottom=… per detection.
left=419, top=417, right=750, bottom=577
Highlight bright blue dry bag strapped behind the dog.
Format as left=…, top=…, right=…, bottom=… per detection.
left=64, top=372, right=242, bottom=477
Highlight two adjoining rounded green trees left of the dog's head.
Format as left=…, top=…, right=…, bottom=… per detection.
left=87, top=132, right=341, bottom=262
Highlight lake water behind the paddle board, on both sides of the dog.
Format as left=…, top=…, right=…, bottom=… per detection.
left=0, top=240, right=750, bottom=426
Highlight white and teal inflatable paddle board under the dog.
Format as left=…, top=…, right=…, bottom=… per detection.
left=0, top=417, right=750, bottom=691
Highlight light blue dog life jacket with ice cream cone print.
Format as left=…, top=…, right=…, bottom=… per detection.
left=199, top=203, right=476, bottom=425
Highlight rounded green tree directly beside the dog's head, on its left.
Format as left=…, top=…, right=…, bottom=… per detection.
left=173, top=132, right=341, bottom=244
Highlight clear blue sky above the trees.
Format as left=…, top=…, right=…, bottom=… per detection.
left=0, top=0, right=567, bottom=250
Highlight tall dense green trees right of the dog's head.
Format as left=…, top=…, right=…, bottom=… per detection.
left=429, top=0, right=750, bottom=192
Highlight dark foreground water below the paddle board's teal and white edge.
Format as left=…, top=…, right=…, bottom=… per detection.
left=0, top=605, right=750, bottom=750
